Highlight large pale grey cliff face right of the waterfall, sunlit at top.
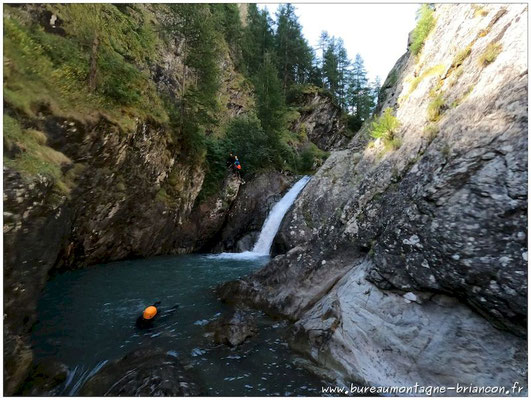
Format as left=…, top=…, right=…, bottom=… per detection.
left=219, top=5, right=528, bottom=391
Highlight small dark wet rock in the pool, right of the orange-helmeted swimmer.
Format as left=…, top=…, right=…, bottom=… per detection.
left=205, top=309, right=258, bottom=347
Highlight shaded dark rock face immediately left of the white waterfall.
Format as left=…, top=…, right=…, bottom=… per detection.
left=214, top=172, right=295, bottom=252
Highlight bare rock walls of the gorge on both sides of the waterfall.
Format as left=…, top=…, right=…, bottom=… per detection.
left=4, top=4, right=528, bottom=395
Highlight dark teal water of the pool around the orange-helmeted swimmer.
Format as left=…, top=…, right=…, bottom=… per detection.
left=32, top=255, right=325, bottom=396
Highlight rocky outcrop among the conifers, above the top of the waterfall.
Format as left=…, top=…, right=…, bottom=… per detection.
left=291, top=93, right=350, bottom=150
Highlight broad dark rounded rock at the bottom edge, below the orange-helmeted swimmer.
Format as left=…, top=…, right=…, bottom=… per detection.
left=80, top=348, right=201, bottom=396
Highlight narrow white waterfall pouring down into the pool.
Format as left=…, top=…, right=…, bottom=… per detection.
left=210, top=176, right=310, bottom=259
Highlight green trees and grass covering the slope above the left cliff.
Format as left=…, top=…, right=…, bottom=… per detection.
left=4, top=4, right=377, bottom=198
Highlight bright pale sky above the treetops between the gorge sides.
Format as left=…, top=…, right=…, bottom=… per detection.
left=259, top=3, right=419, bottom=83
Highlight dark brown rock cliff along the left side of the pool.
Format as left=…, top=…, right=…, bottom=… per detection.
left=4, top=5, right=252, bottom=394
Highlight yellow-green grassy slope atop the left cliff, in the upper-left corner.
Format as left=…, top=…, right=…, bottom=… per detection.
left=4, top=4, right=167, bottom=126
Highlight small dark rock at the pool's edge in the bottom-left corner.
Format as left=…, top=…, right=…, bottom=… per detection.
left=21, top=359, right=68, bottom=396
